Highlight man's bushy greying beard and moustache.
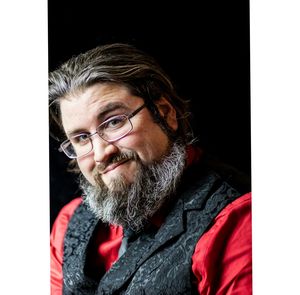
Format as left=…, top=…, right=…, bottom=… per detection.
left=80, top=142, right=186, bottom=232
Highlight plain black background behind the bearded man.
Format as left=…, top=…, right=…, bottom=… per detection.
left=48, top=0, right=251, bottom=226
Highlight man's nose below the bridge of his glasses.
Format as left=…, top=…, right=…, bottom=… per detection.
left=92, top=135, right=118, bottom=163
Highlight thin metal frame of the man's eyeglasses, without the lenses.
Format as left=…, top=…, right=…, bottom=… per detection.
left=58, top=104, right=146, bottom=159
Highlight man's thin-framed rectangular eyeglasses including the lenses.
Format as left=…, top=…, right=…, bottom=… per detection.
left=59, top=104, right=146, bottom=159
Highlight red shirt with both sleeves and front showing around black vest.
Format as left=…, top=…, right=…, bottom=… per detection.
left=50, top=193, right=252, bottom=295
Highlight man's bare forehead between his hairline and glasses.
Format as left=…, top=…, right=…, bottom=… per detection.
left=60, top=83, right=142, bottom=132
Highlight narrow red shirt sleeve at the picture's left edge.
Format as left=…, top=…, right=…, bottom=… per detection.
left=50, top=198, right=82, bottom=295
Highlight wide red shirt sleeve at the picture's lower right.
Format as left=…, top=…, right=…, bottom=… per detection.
left=192, top=193, right=252, bottom=295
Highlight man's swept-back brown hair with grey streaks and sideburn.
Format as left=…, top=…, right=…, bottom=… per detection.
left=49, top=43, right=193, bottom=143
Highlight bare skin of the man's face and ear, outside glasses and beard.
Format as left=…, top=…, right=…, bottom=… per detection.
left=60, top=84, right=178, bottom=187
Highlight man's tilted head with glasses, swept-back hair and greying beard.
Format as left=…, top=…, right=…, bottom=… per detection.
left=49, top=44, right=193, bottom=230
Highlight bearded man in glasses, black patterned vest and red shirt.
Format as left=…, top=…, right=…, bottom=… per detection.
left=49, top=44, right=252, bottom=295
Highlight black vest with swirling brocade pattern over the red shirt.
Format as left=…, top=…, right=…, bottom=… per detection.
left=63, top=163, right=248, bottom=295
